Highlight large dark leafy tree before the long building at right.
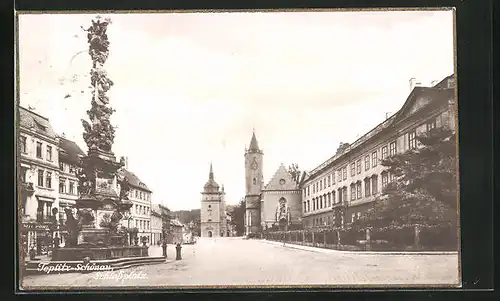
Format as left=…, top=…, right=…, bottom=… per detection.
left=356, top=127, right=457, bottom=226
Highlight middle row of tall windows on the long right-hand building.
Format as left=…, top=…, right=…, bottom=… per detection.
left=302, top=171, right=394, bottom=213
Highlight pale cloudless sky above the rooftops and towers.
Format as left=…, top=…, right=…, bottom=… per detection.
left=19, top=11, right=454, bottom=210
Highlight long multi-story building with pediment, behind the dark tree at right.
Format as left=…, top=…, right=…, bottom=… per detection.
left=301, top=75, right=456, bottom=227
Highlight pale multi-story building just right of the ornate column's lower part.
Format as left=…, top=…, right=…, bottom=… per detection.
left=117, top=159, right=155, bottom=243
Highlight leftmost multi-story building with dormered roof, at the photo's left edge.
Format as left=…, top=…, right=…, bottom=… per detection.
left=18, top=107, right=59, bottom=255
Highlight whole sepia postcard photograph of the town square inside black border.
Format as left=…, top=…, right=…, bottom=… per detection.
left=14, top=8, right=462, bottom=291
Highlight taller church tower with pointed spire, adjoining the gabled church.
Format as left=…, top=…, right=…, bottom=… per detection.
left=245, top=131, right=264, bottom=234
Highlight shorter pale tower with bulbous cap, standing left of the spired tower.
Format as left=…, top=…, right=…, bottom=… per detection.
left=200, top=163, right=226, bottom=237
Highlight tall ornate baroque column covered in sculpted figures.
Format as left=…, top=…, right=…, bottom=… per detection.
left=62, top=17, right=132, bottom=246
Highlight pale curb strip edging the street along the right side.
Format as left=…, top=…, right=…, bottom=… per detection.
left=259, top=240, right=458, bottom=255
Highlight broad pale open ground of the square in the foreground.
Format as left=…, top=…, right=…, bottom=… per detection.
left=22, top=238, right=459, bottom=290
